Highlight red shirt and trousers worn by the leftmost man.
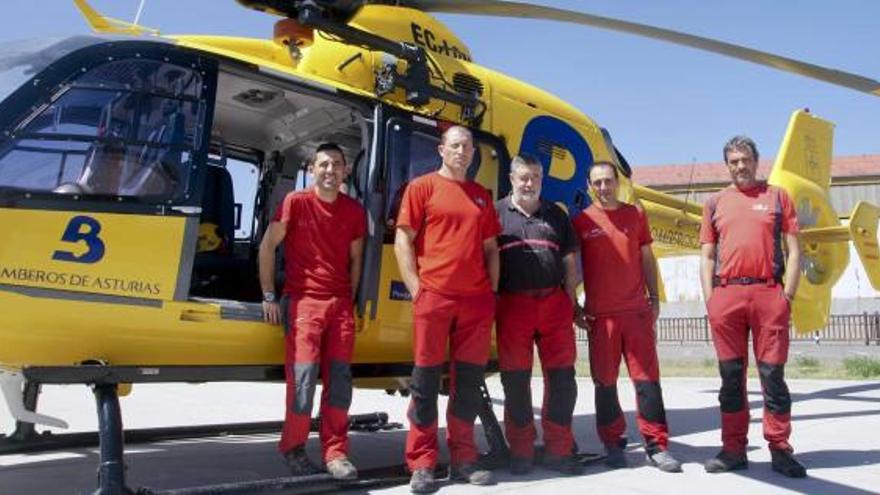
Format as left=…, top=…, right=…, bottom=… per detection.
left=273, top=190, right=366, bottom=462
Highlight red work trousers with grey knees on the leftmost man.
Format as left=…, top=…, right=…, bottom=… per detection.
left=278, top=296, right=354, bottom=462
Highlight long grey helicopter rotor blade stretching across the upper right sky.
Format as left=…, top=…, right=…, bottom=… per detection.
left=398, top=0, right=880, bottom=96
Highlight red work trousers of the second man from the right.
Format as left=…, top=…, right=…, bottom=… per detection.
left=590, top=309, right=669, bottom=453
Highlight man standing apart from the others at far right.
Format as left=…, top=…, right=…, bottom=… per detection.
left=700, top=136, right=807, bottom=478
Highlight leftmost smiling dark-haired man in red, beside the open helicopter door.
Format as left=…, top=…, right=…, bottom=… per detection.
left=259, top=143, right=366, bottom=479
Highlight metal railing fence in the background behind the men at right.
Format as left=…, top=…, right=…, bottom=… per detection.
left=577, top=312, right=880, bottom=345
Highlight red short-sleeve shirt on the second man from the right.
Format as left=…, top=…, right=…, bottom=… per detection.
left=573, top=203, right=653, bottom=315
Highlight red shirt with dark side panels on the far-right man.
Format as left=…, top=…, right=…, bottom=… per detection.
left=700, top=184, right=799, bottom=280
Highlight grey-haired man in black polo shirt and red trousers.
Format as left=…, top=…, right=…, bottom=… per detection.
left=495, top=156, right=583, bottom=474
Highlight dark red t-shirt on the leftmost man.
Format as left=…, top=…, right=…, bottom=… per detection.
left=272, top=189, right=366, bottom=296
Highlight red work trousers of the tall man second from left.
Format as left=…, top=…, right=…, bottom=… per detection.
left=406, top=289, right=495, bottom=470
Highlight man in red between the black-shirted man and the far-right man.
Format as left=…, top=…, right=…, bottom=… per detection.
left=574, top=162, right=681, bottom=473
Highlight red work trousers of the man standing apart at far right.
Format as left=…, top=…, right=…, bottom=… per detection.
left=707, top=284, right=791, bottom=453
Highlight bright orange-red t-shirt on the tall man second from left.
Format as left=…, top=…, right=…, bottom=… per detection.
left=397, top=172, right=501, bottom=295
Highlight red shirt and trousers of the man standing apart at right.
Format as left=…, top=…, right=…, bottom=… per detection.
left=700, top=184, right=798, bottom=454
